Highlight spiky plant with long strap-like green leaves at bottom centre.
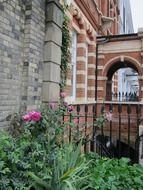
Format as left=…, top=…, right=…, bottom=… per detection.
left=29, top=144, right=89, bottom=190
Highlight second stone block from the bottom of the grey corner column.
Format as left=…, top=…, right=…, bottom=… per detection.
left=43, top=62, right=60, bottom=83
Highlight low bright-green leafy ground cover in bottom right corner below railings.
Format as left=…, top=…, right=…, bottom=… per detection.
left=89, top=158, right=143, bottom=190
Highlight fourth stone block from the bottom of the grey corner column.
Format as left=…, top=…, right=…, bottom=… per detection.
left=45, top=22, right=62, bottom=46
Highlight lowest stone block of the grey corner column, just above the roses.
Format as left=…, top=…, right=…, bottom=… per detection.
left=42, top=82, right=60, bottom=103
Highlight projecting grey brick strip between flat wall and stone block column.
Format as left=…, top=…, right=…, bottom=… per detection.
left=21, top=0, right=45, bottom=110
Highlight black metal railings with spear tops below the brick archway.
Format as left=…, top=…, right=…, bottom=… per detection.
left=63, top=104, right=141, bottom=163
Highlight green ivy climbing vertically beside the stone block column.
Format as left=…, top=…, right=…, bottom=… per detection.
left=60, top=8, right=71, bottom=91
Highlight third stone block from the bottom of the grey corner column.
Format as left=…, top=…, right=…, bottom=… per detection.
left=44, top=42, right=61, bottom=65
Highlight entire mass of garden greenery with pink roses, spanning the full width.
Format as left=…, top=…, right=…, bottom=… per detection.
left=0, top=103, right=143, bottom=190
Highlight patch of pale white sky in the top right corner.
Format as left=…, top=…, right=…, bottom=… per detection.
left=130, top=0, right=143, bottom=32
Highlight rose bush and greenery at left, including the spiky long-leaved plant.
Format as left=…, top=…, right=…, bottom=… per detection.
left=0, top=104, right=88, bottom=190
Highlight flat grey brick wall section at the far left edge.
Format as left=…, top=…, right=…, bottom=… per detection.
left=0, top=0, right=25, bottom=126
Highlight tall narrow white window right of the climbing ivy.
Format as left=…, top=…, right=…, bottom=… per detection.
left=71, top=31, right=77, bottom=100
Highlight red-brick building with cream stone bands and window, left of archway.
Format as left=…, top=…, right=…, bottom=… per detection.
left=65, top=0, right=119, bottom=103
